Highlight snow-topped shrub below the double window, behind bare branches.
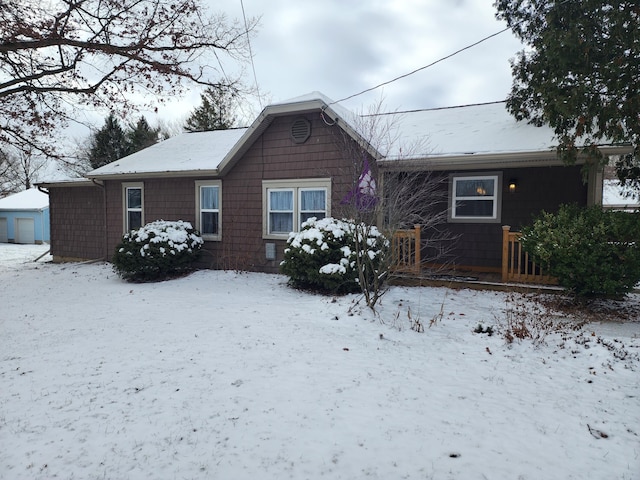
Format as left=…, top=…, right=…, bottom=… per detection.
left=280, top=218, right=388, bottom=293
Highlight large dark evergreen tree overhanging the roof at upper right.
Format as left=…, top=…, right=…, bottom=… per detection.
left=494, top=0, right=640, bottom=191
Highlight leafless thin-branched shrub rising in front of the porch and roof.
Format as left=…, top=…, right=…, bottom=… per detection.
left=336, top=100, right=455, bottom=308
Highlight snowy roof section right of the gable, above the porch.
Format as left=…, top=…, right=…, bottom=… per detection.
left=382, top=102, right=631, bottom=169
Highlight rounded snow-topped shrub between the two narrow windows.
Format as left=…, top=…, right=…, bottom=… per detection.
left=111, top=220, right=204, bottom=282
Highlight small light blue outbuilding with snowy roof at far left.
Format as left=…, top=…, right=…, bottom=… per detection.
left=0, top=188, right=49, bottom=244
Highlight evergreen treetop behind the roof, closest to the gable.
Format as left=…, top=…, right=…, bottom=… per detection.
left=184, top=85, right=237, bottom=132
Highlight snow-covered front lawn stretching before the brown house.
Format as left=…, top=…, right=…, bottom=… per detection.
left=0, top=244, right=640, bottom=480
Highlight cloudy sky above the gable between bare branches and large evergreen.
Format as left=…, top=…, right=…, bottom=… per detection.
left=196, top=0, right=522, bottom=117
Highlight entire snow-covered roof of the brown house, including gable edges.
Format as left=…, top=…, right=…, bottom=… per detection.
left=82, top=92, right=628, bottom=178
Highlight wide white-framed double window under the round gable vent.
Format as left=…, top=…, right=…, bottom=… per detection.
left=262, top=178, right=331, bottom=239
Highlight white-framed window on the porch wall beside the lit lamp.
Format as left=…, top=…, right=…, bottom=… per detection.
left=449, top=172, right=502, bottom=223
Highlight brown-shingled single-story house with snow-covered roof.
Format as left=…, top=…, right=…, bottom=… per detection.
left=40, top=92, right=629, bottom=272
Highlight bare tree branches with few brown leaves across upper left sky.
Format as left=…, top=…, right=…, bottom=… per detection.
left=0, top=0, right=257, bottom=156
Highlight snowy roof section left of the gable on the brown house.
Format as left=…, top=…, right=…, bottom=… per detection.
left=87, top=128, right=247, bottom=178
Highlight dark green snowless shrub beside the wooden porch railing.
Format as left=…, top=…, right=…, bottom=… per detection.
left=521, top=205, right=640, bottom=297
